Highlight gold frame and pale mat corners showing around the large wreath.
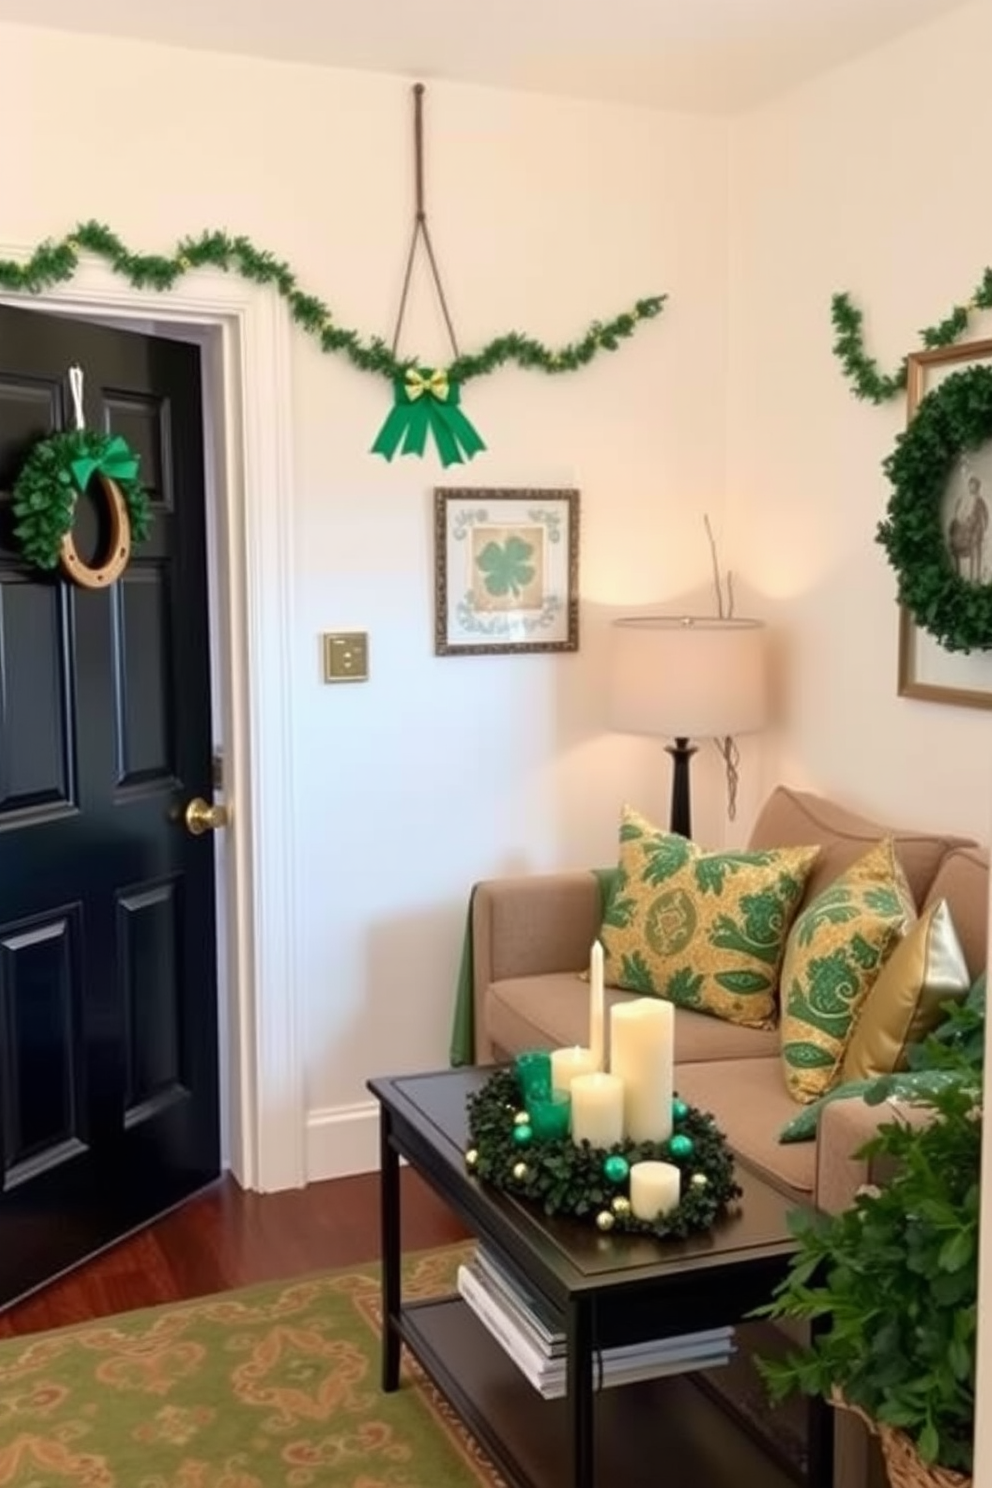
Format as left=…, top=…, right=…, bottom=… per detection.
left=898, top=339, right=992, bottom=708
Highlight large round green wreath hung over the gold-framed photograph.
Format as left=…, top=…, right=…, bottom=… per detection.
left=876, top=366, right=992, bottom=652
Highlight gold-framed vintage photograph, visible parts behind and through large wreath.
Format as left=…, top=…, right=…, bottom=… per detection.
left=898, top=341, right=992, bottom=708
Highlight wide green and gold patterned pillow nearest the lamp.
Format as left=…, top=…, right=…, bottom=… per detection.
left=599, top=806, right=819, bottom=1028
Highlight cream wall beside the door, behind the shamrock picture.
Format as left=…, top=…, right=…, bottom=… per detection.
left=0, top=14, right=727, bottom=1176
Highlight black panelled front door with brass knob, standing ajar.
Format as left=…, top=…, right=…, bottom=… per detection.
left=0, top=307, right=219, bottom=1305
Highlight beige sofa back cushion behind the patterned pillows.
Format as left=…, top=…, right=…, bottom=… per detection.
left=748, top=786, right=988, bottom=910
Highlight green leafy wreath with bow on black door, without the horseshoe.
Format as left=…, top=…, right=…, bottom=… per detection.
left=10, top=429, right=152, bottom=570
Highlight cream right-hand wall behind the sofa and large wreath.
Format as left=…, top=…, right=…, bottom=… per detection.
left=727, top=3, right=992, bottom=841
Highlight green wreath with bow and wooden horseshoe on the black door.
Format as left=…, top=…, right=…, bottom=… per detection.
left=12, top=429, right=150, bottom=588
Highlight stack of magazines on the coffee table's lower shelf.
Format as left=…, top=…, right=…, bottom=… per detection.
left=458, top=1245, right=733, bottom=1400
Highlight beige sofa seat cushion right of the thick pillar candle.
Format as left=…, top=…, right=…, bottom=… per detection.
left=675, top=1059, right=817, bottom=1193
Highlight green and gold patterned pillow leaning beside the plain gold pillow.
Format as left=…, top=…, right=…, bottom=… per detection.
left=782, top=838, right=916, bottom=1103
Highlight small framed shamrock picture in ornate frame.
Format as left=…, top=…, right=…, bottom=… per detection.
left=434, top=487, right=579, bottom=656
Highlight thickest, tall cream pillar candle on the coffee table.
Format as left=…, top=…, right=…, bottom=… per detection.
left=610, top=997, right=675, bottom=1141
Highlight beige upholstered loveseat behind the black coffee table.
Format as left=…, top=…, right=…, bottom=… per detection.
left=471, top=786, right=989, bottom=1488
